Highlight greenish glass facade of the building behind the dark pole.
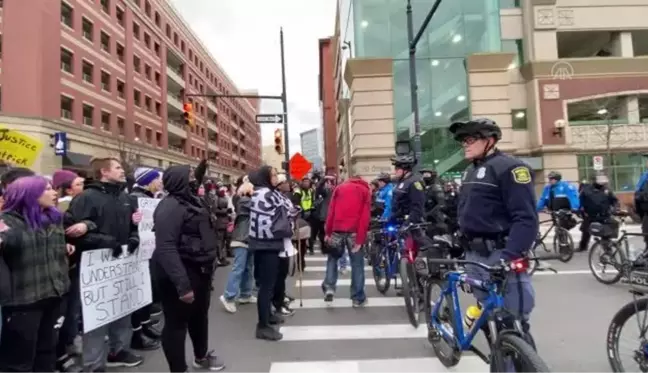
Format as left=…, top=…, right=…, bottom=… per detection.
left=352, top=0, right=503, bottom=172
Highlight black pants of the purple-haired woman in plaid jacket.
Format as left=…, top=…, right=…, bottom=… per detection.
left=0, top=298, right=65, bottom=373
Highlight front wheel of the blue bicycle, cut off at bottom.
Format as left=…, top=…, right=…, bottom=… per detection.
left=490, top=333, right=550, bottom=373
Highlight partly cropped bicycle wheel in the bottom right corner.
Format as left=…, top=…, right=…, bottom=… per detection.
left=606, top=297, right=648, bottom=373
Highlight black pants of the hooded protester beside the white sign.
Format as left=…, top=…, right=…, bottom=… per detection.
left=156, top=266, right=212, bottom=373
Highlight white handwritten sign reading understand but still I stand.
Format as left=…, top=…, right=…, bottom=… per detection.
left=80, top=248, right=153, bottom=333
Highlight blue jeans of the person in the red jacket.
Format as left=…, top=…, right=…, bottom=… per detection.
left=322, top=233, right=367, bottom=302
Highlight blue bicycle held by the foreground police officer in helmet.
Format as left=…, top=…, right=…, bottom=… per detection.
left=425, top=258, right=549, bottom=373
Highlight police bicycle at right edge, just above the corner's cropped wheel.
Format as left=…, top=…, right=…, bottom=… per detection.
left=588, top=211, right=648, bottom=285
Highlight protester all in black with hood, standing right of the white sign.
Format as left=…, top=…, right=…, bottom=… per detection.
left=152, top=165, right=225, bottom=373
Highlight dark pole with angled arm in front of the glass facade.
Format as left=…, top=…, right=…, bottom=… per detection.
left=406, top=0, right=441, bottom=170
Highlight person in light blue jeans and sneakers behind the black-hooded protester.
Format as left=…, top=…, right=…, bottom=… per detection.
left=220, top=182, right=257, bottom=313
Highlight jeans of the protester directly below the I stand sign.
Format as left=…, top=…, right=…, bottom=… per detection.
left=83, top=315, right=133, bottom=371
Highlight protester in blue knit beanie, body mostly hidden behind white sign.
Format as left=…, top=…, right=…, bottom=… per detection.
left=130, top=167, right=162, bottom=351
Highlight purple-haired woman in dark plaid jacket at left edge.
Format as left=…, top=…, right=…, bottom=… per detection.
left=0, top=176, right=74, bottom=373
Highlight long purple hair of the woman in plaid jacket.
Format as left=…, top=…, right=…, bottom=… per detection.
left=2, top=176, right=62, bottom=229
